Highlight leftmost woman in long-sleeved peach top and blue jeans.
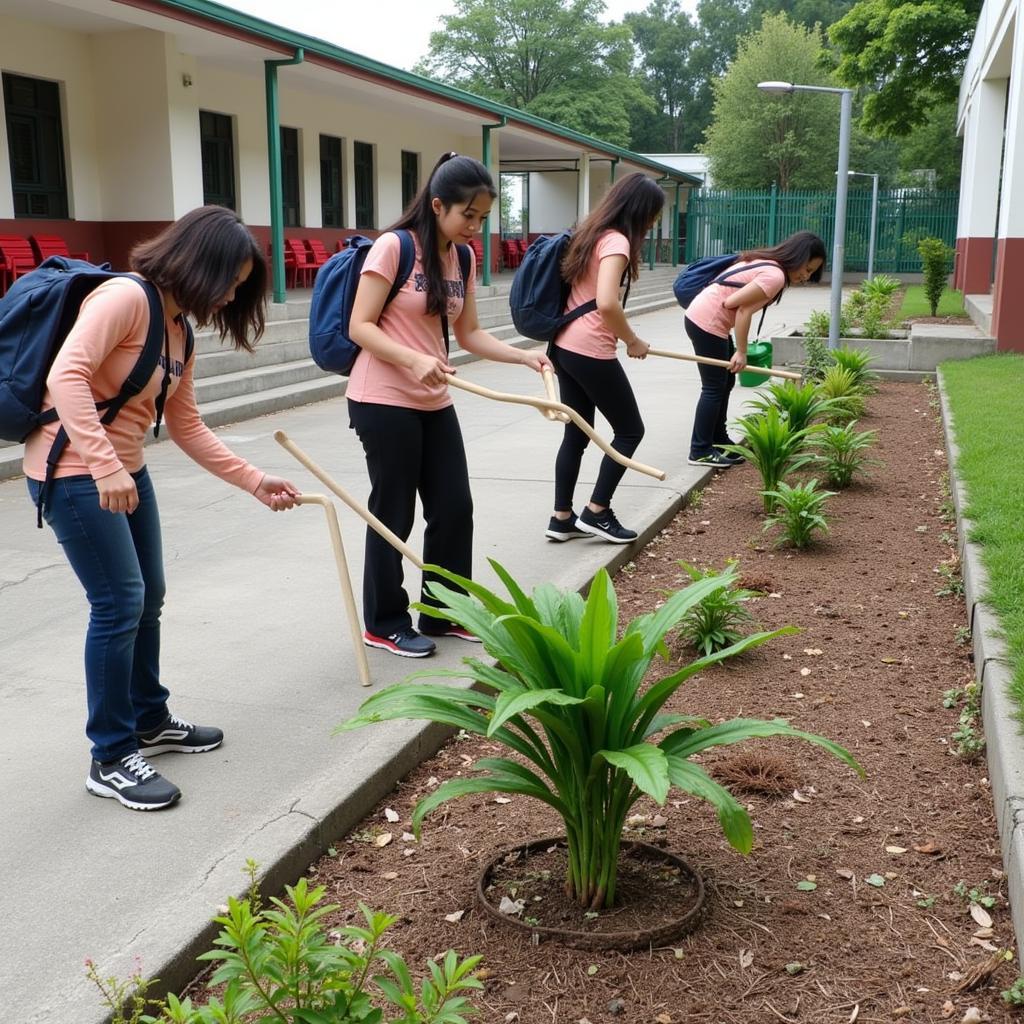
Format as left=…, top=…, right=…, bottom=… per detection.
left=25, top=207, right=299, bottom=811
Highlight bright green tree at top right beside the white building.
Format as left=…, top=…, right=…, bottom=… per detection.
left=828, top=0, right=981, bottom=136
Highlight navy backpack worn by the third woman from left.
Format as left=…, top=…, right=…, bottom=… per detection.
left=509, top=231, right=629, bottom=343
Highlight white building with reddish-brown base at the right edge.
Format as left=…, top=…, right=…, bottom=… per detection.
left=953, top=0, right=1024, bottom=352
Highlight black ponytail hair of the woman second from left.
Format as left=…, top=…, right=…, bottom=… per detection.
left=388, top=153, right=498, bottom=315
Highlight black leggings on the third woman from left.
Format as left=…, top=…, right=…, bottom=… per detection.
left=551, top=346, right=643, bottom=512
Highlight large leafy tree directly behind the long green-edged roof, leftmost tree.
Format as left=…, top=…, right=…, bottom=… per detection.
left=417, top=0, right=651, bottom=145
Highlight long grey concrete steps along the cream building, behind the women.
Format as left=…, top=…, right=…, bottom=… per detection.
left=0, top=265, right=682, bottom=480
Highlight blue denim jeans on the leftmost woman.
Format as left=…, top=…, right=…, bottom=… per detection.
left=28, top=468, right=169, bottom=761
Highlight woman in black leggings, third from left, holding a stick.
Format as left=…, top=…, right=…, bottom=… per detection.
left=545, top=172, right=665, bottom=544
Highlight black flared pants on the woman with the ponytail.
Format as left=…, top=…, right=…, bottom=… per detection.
left=348, top=399, right=473, bottom=637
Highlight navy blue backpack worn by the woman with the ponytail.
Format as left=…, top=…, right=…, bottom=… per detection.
left=309, top=228, right=472, bottom=377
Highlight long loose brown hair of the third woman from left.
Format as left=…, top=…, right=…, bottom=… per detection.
left=562, top=171, right=665, bottom=283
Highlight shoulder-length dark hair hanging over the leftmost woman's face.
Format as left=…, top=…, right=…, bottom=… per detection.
left=128, top=206, right=266, bottom=352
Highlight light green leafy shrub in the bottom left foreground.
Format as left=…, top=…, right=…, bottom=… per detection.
left=141, top=879, right=483, bottom=1024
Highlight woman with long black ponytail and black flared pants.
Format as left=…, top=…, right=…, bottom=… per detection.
left=346, top=153, right=549, bottom=657
